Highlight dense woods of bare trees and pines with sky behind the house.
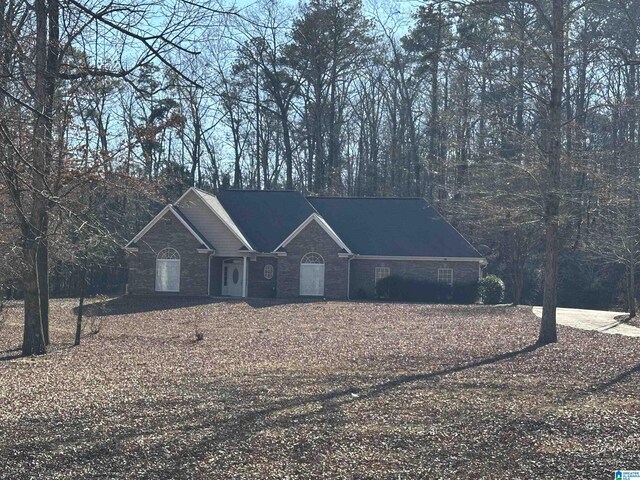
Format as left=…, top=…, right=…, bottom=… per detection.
left=0, top=0, right=640, bottom=342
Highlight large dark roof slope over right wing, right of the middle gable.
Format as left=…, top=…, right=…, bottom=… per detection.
left=308, top=197, right=482, bottom=260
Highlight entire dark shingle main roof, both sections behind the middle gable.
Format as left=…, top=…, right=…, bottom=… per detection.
left=210, top=190, right=482, bottom=259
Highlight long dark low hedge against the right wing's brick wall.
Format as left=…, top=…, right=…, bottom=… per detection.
left=376, top=275, right=478, bottom=303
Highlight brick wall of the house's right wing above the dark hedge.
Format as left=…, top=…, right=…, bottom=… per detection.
left=349, top=259, right=479, bottom=298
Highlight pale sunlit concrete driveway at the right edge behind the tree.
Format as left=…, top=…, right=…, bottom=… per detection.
left=533, top=307, right=640, bottom=337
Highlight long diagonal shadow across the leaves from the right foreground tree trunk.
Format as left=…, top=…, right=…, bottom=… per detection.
left=2, top=344, right=540, bottom=478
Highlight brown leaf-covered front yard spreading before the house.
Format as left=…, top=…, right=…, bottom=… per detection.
left=0, top=299, right=640, bottom=480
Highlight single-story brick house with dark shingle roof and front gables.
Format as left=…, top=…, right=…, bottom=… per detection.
left=125, top=188, right=486, bottom=299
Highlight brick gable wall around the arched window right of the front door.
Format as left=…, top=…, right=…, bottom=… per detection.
left=276, top=221, right=347, bottom=298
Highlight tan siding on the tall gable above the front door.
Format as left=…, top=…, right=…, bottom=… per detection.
left=178, top=192, right=243, bottom=257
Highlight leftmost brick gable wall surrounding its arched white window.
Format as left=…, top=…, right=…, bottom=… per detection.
left=128, top=212, right=209, bottom=295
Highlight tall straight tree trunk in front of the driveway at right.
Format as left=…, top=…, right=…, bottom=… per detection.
left=538, top=0, right=564, bottom=345
